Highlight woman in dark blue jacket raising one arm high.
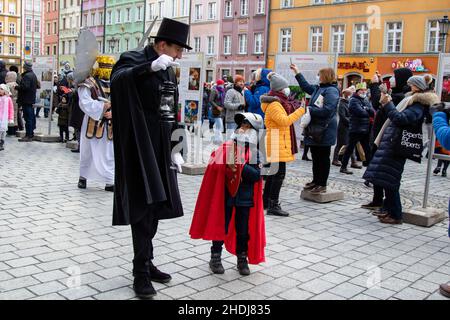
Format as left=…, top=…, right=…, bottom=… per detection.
left=290, top=64, right=340, bottom=194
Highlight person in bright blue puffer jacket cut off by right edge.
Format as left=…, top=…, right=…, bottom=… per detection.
left=433, top=103, right=450, bottom=298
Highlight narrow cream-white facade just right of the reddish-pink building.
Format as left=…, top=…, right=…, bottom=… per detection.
left=58, top=0, right=81, bottom=67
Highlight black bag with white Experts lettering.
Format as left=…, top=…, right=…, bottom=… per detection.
left=394, top=126, right=423, bottom=163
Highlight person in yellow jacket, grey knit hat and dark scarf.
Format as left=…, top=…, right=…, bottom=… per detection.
left=260, top=72, right=306, bottom=217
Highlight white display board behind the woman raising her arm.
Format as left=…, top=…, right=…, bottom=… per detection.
left=275, top=52, right=338, bottom=86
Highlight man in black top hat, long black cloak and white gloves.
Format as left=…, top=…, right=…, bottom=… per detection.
left=111, top=18, right=192, bottom=298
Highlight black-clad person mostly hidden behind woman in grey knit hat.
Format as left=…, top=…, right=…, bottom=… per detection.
left=361, top=68, right=413, bottom=210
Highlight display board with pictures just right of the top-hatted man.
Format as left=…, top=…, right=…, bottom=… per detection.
left=175, top=53, right=205, bottom=125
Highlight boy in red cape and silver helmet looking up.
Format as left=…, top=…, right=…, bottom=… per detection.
left=189, top=112, right=266, bottom=275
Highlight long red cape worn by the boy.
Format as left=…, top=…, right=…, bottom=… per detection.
left=189, top=142, right=266, bottom=264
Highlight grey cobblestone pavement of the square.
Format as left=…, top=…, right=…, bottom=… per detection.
left=0, top=117, right=450, bottom=300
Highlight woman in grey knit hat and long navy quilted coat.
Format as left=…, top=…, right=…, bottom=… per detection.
left=363, top=75, right=439, bottom=224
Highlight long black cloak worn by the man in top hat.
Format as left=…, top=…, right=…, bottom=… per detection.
left=111, top=46, right=185, bottom=225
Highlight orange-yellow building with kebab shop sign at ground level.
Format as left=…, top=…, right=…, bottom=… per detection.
left=267, top=0, right=450, bottom=87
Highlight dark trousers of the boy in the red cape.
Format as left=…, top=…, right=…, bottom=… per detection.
left=211, top=206, right=250, bottom=254
